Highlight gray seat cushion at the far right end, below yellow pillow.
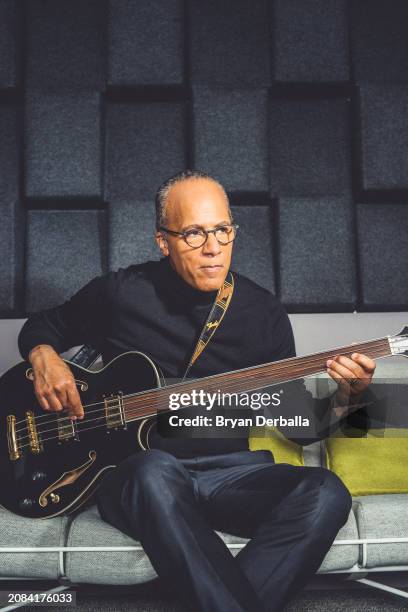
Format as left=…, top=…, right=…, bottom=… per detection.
left=354, top=494, right=408, bottom=568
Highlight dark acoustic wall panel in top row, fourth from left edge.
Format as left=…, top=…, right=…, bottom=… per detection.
left=188, top=0, right=271, bottom=87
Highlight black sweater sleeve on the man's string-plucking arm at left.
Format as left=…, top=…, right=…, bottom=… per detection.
left=18, top=272, right=115, bottom=359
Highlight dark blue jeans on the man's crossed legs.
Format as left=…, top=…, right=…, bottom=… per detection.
left=98, top=450, right=351, bottom=612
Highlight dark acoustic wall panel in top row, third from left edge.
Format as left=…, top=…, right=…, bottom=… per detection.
left=108, top=0, right=184, bottom=85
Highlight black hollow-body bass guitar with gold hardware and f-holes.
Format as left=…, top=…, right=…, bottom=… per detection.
left=0, top=327, right=408, bottom=519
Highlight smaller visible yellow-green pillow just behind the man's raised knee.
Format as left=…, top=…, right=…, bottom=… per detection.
left=249, top=427, right=304, bottom=465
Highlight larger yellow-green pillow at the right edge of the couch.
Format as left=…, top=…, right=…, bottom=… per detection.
left=325, top=428, right=408, bottom=495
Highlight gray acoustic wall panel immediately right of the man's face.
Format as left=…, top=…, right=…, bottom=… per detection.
left=231, top=206, right=275, bottom=293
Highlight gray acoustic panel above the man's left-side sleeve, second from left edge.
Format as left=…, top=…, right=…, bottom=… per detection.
left=26, top=210, right=105, bottom=312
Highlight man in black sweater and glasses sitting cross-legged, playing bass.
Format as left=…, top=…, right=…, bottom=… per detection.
left=19, top=171, right=375, bottom=612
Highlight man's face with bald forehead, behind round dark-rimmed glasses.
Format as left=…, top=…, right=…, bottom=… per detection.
left=156, top=178, right=233, bottom=291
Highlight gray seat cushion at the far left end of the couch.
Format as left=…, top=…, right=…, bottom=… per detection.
left=0, top=507, right=68, bottom=579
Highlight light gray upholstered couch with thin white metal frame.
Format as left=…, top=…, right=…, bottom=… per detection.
left=0, top=360, right=408, bottom=609
